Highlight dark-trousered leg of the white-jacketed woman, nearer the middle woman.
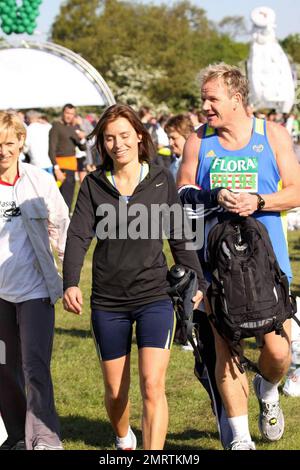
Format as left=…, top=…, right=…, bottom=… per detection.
left=17, top=299, right=62, bottom=450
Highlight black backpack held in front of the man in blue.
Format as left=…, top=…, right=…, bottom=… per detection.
left=207, top=217, right=298, bottom=369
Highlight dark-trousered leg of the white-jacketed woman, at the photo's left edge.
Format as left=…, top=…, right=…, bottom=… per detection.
left=0, top=299, right=26, bottom=446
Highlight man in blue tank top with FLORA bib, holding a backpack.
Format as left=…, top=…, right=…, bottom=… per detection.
left=178, top=63, right=300, bottom=450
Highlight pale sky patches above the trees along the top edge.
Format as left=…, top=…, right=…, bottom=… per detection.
left=35, top=0, right=300, bottom=40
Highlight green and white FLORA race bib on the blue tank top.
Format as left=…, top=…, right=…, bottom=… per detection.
left=210, top=157, right=258, bottom=192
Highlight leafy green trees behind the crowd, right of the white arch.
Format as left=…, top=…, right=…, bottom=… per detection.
left=52, top=0, right=247, bottom=111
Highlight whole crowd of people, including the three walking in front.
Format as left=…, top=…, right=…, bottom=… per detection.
left=0, top=64, right=300, bottom=450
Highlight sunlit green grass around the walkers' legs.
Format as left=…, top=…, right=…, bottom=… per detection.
left=52, top=232, right=300, bottom=450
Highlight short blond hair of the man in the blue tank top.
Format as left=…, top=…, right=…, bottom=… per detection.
left=200, top=62, right=249, bottom=108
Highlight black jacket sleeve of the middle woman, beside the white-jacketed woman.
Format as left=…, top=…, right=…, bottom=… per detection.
left=63, top=177, right=95, bottom=290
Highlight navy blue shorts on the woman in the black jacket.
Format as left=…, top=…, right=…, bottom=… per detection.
left=91, top=299, right=176, bottom=361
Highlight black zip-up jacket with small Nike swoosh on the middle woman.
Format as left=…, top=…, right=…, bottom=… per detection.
left=63, top=165, right=207, bottom=311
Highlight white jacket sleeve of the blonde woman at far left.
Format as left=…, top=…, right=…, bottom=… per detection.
left=15, top=162, right=69, bottom=304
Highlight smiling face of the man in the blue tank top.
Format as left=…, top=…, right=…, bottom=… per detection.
left=201, top=79, right=237, bottom=128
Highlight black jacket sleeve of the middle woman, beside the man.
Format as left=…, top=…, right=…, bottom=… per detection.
left=167, top=173, right=207, bottom=293
